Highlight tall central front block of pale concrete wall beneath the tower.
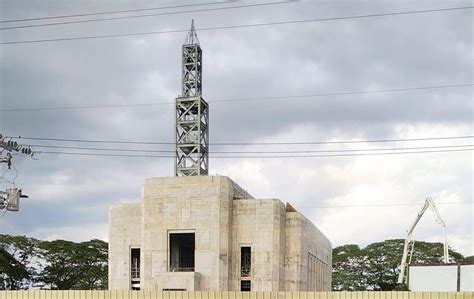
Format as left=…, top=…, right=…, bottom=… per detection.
left=141, top=176, right=232, bottom=291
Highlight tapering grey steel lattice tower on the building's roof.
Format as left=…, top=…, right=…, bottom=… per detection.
left=175, top=20, right=209, bottom=176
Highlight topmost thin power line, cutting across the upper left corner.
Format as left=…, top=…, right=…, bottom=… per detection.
left=0, top=0, right=239, bottom=23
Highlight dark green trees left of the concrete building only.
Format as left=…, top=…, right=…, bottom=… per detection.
left=0, top=235, right=108, bottom=290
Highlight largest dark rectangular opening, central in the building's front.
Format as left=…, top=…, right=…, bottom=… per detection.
left=170, top=233, right=195, bottom=272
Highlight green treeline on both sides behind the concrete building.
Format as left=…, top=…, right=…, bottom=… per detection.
left=0, top=235, right=474, bottom=291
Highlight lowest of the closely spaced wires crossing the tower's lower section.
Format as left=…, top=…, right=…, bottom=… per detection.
left=40, top=148, right=474, bottom=159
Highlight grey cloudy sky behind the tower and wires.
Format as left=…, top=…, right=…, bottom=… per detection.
left=0, top=0, right=474, bottom=255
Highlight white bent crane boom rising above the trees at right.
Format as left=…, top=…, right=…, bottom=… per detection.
left=398, top=197, right=449, bottom=283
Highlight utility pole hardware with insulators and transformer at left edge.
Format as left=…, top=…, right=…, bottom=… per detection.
left=0, top=133, right=36, bottom=215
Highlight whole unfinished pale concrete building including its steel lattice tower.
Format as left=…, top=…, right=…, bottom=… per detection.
left=109, top=21, right=332, bottom=291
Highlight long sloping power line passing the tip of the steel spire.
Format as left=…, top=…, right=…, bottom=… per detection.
left=0, top=6, right=474, bottom=45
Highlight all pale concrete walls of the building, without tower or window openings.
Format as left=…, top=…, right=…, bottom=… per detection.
left=109, top=176, right=331, bottom=291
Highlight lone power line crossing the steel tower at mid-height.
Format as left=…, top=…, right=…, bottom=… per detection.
left=0, top=83, right=474, bottom=112
